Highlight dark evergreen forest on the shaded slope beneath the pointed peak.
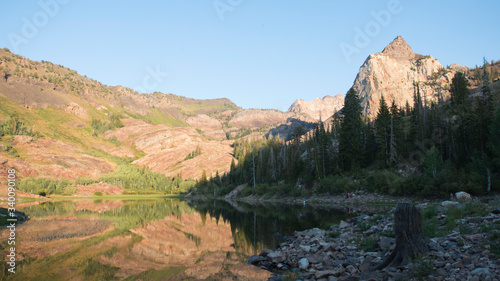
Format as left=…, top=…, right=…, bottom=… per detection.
left=194, top=70, right=500, bottom=196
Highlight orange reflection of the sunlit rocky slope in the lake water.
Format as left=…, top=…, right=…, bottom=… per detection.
left=100, top=213, right=270, bottom=280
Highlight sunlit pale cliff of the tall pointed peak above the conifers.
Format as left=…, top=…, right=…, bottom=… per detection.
left=353, top=36, right=464, bottom=119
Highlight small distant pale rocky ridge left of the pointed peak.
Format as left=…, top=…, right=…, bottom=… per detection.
left=288, top=94, right=344, bottom=122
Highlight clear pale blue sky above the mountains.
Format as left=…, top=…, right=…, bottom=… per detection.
left=0, top=0, right=500, bottom=110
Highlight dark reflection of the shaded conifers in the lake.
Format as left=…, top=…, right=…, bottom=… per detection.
left=191, top=198, right=352, bottom=255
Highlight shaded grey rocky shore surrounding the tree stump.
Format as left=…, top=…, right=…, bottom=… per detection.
left=249, top=198, right=500, bottom=281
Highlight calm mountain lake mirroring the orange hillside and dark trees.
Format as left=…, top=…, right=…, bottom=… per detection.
left=0, top=198, right=356, bottom=280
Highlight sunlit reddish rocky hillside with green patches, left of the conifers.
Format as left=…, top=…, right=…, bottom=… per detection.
left=0, top=49, right=340, bottom=196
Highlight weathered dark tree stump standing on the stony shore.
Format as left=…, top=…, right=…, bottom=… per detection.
left=375, top=203, right=429, bottom=270
